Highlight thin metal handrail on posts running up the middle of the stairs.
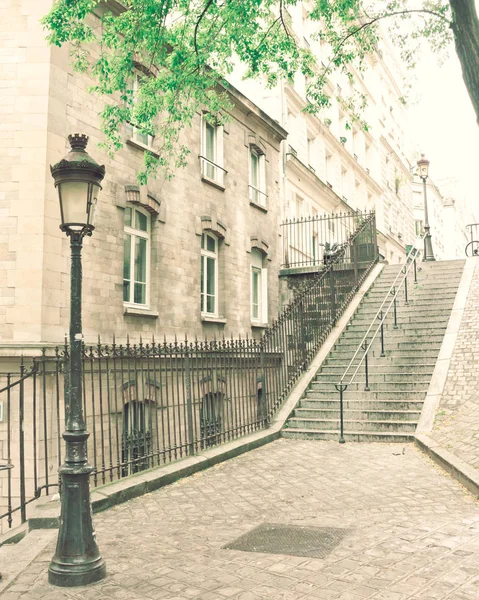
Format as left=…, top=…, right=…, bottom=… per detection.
left=335, top=236, right=424, bottom=444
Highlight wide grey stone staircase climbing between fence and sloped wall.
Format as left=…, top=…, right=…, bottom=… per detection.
left=282, top=260, right=465, bottom=442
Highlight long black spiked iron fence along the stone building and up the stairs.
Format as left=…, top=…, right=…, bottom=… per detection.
left=0, top=214, right=377, bottom=528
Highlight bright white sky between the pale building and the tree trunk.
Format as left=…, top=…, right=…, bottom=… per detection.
left=409, top=2, right=479, bottom=220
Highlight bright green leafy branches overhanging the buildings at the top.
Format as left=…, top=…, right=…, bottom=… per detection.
left=44, top=0, right=479, bottom=181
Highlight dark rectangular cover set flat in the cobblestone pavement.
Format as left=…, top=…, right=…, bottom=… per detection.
left=223, top=523, right=351, bottom=558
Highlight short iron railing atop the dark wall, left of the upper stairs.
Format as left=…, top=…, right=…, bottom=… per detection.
left=281, top=211, right=371, bottom=268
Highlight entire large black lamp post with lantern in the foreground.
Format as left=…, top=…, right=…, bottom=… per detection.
left=48, top=134, right=106, bottom=587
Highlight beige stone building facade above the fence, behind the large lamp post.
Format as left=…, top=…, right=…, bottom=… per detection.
left=0, top=0, right=286, bottom=352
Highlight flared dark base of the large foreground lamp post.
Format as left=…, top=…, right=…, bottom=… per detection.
left=48, top=465, right=106, bottom=587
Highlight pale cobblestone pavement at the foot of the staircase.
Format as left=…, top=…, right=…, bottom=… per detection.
left=2, top=440, right=479, bottom=600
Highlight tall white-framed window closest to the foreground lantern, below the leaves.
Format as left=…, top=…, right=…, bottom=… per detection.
left=123, top=207, right=150, bottom=306
